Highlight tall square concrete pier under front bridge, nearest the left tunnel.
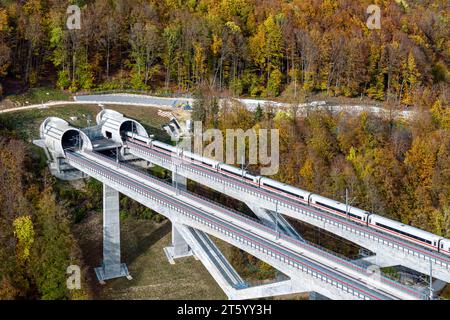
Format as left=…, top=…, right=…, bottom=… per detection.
left=95, top=184, right=132, bottom=283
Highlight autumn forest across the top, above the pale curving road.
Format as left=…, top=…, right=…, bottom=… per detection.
left=0, top=0, right=450, bottom=105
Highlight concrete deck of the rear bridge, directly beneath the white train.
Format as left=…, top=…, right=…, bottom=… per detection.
left=126, top=140, right=450, bottom=282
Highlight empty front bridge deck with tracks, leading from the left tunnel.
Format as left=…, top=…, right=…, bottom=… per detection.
left=67, top=153, right=426, bottom=299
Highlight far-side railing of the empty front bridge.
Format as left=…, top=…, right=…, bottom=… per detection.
left=84, top=152, right=425, bottom=299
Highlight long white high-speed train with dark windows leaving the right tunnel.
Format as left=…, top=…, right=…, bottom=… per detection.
left=128, top=133, right=450, bottom=256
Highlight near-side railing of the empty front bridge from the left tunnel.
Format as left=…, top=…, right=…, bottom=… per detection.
left=66, top=152, right=382, bottom=300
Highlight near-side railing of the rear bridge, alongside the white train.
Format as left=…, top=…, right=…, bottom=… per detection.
left=128, top=140, right=450, bottom=270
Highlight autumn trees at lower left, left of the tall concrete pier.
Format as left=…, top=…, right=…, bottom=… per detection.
left=0, top=134, right=87, bottom=300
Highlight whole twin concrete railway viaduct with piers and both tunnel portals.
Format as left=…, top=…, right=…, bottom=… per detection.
left=35, top=112, right=450, bottom=300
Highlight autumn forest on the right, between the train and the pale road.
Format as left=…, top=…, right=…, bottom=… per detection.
left=193, top=90, right=450, bottom=237
